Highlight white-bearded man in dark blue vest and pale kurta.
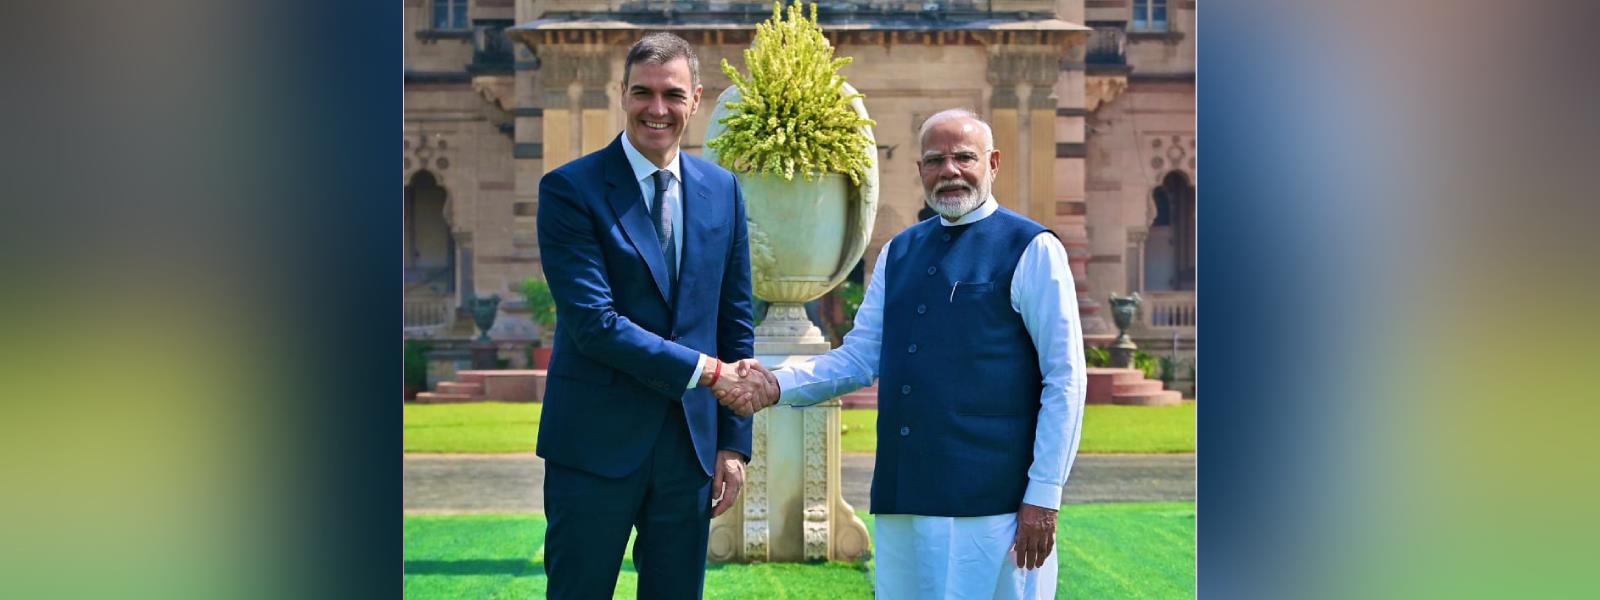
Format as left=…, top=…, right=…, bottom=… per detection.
left=725, top=110, right=1086, bottom=598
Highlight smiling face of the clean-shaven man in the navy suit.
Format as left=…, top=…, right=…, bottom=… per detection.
left=622, top=58, right=701, bottom=166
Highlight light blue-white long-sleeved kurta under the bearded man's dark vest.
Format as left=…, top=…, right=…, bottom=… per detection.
left=774, top=197, right=1088, bottom=598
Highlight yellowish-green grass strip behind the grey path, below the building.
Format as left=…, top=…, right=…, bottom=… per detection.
left=405, top=402, right=1195, bottom=454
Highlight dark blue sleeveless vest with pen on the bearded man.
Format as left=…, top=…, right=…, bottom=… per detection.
left=872, top=208, right=1046, bottom=517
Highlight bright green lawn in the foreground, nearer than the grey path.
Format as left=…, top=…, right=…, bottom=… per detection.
left=405, top=502, right=1195, bottom=600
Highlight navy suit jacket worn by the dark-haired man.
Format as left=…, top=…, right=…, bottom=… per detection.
left=538, top=136, right=755, bottom=477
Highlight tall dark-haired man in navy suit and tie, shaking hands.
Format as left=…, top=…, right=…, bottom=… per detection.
left=538, top=34, right=778, bottom=598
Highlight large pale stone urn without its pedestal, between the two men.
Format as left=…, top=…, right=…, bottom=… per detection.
left=706, top=83, right=878, bottom=342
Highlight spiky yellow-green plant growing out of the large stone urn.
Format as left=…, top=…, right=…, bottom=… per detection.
left=707, top=0, right=875, bottom=186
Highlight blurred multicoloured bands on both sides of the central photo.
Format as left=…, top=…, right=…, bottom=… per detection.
left=0, top=0, right=1600, bottom=598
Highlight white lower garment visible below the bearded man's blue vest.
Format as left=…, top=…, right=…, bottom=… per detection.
left=874, top=512, right=1059, bottom=600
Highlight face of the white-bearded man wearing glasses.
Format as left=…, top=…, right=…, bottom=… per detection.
left=917, top=117, right=1000, bottom=221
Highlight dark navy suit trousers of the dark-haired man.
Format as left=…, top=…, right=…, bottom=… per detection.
left=544, top=406, right=712, bottom=598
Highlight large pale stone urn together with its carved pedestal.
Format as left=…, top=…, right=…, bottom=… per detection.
left=706, top=83, right=878, bottom=562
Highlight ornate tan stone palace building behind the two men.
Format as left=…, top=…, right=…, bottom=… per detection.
left=403, top=0, right=1197, bottom=366
